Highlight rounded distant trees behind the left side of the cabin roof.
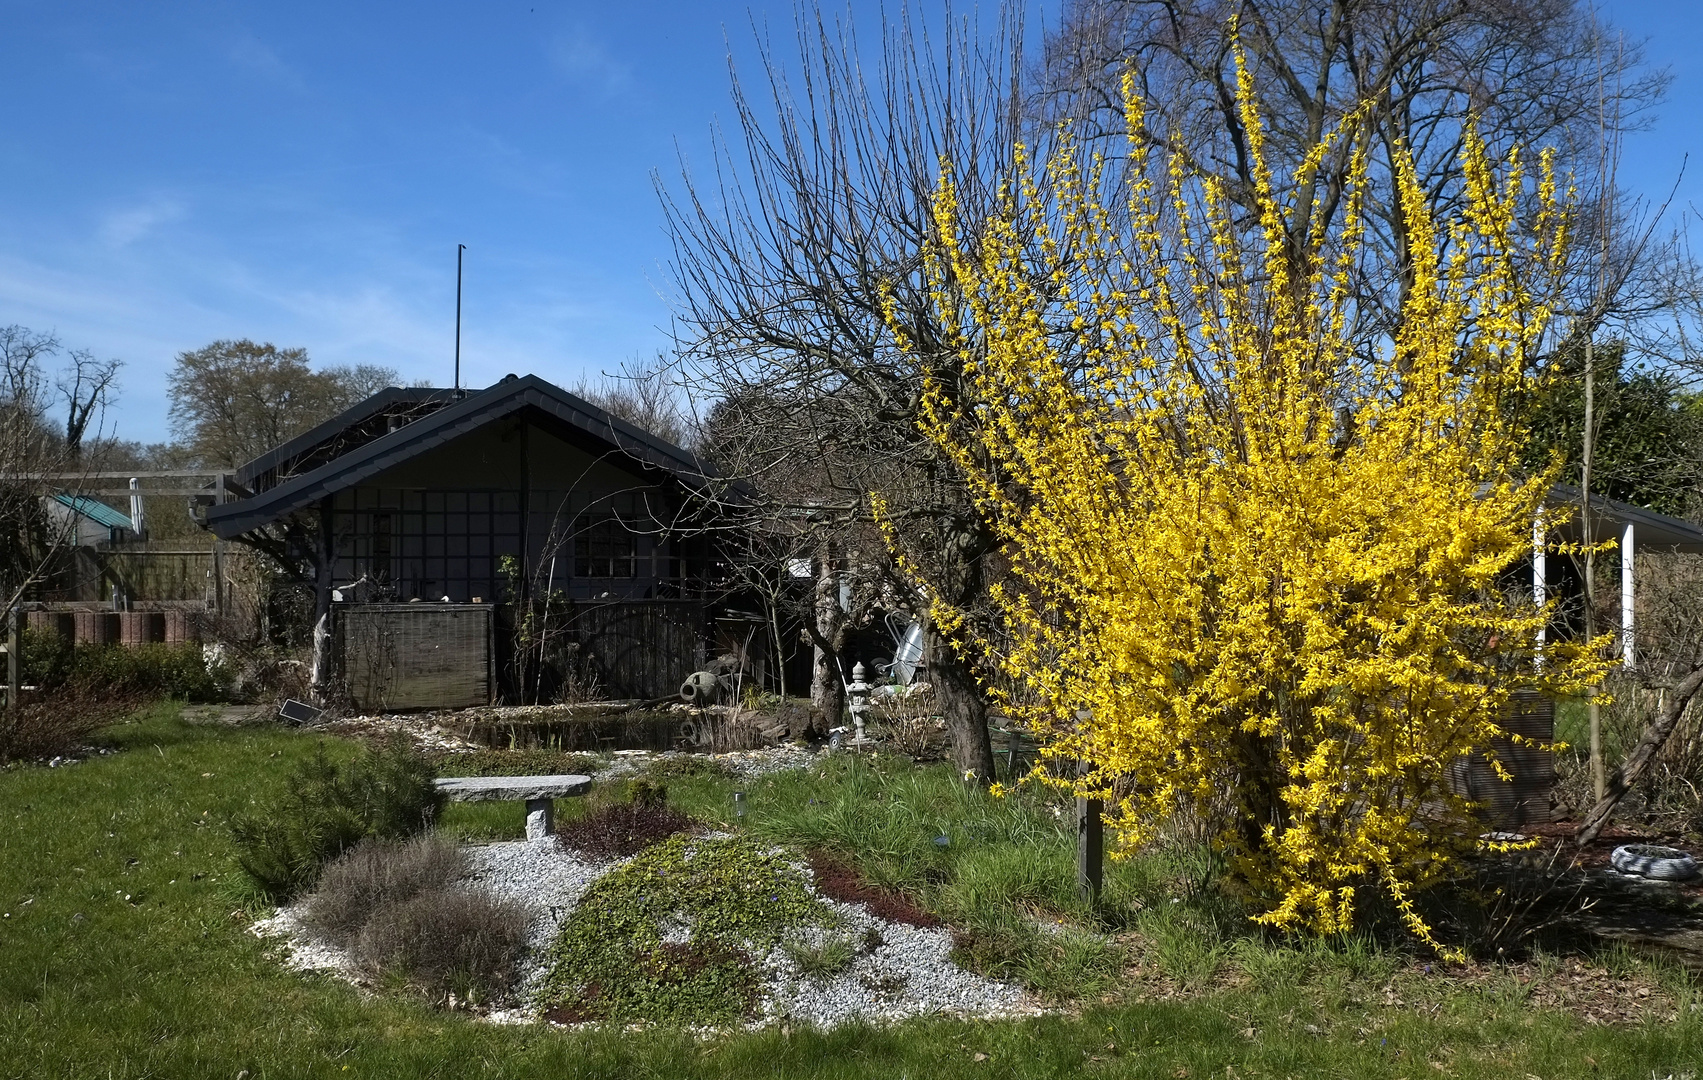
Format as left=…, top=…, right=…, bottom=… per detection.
left=169, top=339, right=399, bottom=468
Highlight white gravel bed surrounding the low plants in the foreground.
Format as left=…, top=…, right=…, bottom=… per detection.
left=250, top=836, right=1042, bottom=1027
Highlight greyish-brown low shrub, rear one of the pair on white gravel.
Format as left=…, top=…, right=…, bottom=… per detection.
left=303, top=833, right=467, bottom=945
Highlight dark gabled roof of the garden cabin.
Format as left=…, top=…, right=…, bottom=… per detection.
left=206, top=375, right=744, bottom=540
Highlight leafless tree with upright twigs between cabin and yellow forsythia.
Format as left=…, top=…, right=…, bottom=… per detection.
left=662, top=7, right=1049, bottom=782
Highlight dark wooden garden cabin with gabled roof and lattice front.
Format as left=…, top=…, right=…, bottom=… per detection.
left=204, top=375, right=741, bottom=709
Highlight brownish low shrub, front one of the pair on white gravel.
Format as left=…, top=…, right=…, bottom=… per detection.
left=351, top=886, right=531, bottom=1002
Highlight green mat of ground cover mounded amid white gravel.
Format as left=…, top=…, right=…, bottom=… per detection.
left=540, top=836, right=836, bottom=1024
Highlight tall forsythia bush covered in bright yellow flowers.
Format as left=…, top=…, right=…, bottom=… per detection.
left=877, top=63, right=1603, bottom=940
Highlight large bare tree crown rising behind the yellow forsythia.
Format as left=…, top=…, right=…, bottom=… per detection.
left=1037, top=0, right=1667, bottom=334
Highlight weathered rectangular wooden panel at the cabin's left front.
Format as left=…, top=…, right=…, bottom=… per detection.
left=332, top=603, right=492, bottom=712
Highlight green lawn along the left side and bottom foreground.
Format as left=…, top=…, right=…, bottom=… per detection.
left=0, top=705, right=1703, bottom=1080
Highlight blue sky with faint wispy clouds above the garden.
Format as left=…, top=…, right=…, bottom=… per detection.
left=0, top=0, right=1703, bottom=441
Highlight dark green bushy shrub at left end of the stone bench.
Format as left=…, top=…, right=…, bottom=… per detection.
left=230, top=738, right=444, bottom=903
